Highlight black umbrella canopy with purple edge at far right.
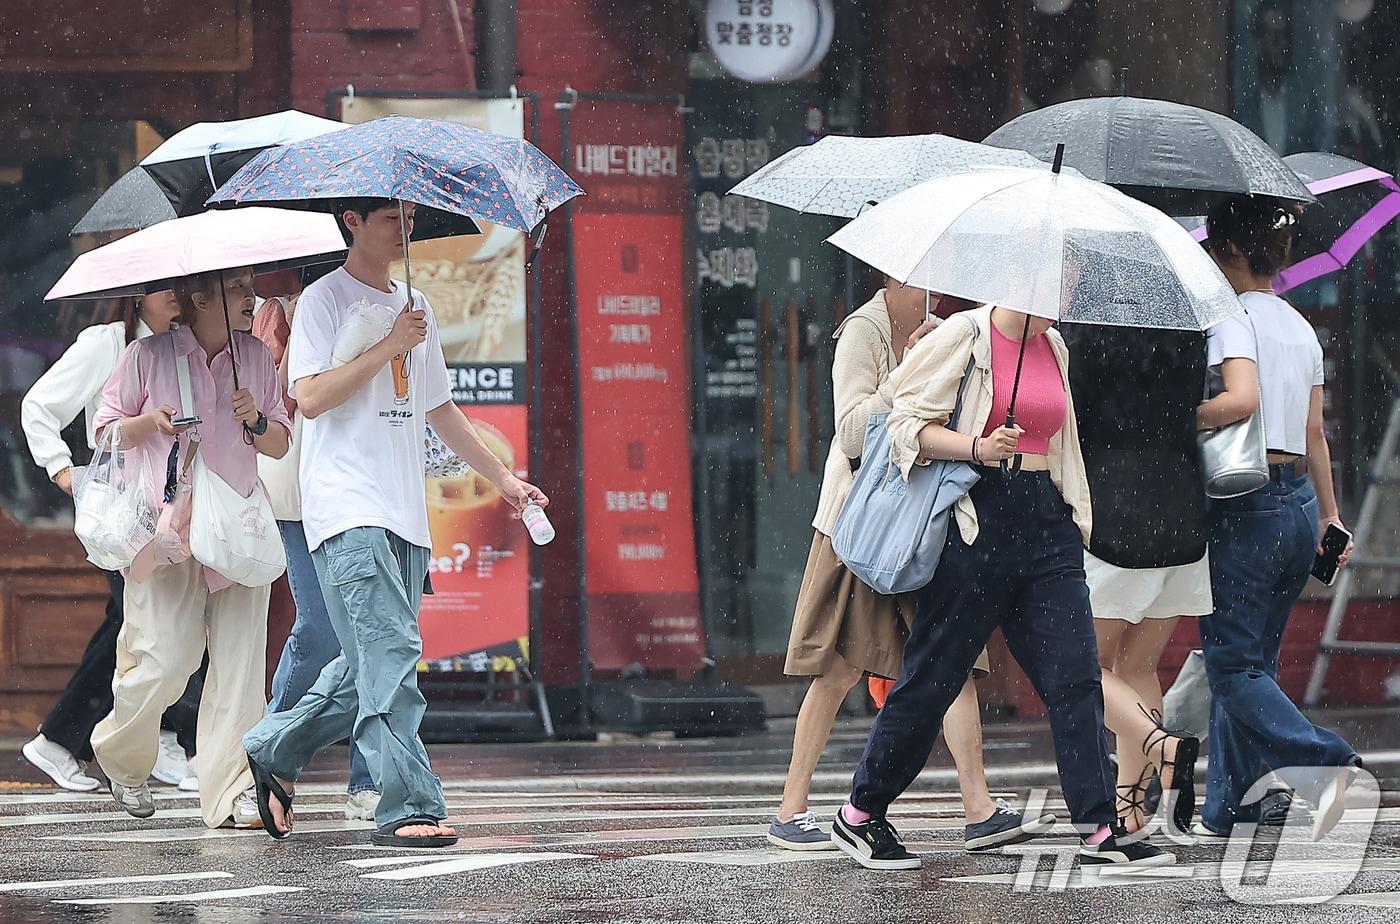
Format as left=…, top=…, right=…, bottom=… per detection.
left=1182, top=151, right=1400, bottom=293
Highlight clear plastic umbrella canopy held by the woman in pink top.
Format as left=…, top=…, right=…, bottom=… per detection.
left=827, top=168, right=1240, bottom=330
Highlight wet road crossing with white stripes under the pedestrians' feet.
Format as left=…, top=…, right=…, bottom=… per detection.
left=0, top=777, right=1400, bottom=920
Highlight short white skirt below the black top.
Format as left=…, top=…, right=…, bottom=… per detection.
left=1084, top=550, right=1215, bottom=624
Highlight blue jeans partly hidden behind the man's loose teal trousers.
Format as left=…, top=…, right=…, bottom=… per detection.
left=267, top=519, right=374, bottom=792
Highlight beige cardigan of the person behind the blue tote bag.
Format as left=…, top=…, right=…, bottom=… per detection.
left=812, top=288, right=897, bottom=536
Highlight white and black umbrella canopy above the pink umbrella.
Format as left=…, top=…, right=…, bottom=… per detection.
left=141, top=109, right=346, bottom=216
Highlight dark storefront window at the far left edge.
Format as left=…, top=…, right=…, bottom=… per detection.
left=0, top=122, right=150, bottom=528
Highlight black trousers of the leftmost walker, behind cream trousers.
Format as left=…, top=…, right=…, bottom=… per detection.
left=39, top=571, right=209, bottom=760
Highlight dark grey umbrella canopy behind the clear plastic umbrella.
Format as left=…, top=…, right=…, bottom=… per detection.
left=986, top=97, right=1315, bottom=216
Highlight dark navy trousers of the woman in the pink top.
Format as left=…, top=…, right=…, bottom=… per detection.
left=851, top=469, right=1114, bottom=827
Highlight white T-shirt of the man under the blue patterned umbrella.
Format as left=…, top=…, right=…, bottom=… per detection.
left=287, top=267, right=452, bottom=550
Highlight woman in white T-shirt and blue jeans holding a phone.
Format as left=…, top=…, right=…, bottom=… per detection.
left=1193, top=196, right=1361, bottom=840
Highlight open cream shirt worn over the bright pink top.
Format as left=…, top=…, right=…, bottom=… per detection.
left=889, top=305, right=1093, bottom=547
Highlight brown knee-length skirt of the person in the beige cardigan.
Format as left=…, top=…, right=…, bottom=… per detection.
left=783, top=531, right=988, bottom=680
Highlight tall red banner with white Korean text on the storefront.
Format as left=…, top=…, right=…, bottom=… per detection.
left=570, top=99, right=706, bottom=671
